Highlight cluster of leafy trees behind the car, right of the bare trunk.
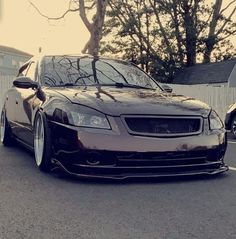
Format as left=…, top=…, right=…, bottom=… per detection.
left=103, top=0, right=236, bottom=80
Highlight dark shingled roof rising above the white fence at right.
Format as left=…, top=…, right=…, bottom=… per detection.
left=173, top=59, right=236, bottom=85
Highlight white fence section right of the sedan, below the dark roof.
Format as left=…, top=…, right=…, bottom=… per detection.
left=169, top=84, right=236, bottom=120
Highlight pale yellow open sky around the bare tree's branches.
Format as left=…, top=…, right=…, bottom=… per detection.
left=0, top=0, right=236, bottom=54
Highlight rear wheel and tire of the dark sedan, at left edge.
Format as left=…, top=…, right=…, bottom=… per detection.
left=0, top=110, right=14, bottom=146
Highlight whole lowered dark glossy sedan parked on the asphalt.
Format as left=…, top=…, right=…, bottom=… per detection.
left=1, top=55, right=228, bottom=179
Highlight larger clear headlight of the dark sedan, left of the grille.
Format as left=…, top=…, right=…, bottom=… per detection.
left=54, top=104, right=111, bottom=129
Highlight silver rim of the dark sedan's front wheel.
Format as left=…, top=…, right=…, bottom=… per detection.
left=34, top=115, right=44, bottom=166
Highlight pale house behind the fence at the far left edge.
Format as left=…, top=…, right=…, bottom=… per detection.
left=0, top=46, right=32, bottom=77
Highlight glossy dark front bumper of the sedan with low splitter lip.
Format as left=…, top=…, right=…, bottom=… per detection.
left=48, top=120, right=228, bottom=179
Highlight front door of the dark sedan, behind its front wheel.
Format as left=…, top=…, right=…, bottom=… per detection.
left=15, top=60, right=38, bottom=147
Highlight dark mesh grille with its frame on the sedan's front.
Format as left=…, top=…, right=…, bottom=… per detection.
left=122, top=116, right=203, bottom=137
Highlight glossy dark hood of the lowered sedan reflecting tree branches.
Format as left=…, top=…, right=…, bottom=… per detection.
left=52, top=87, right=211, bottom=117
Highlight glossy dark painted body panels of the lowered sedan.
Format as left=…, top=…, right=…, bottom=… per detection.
left=0, top=55, right=228, bottom=179
